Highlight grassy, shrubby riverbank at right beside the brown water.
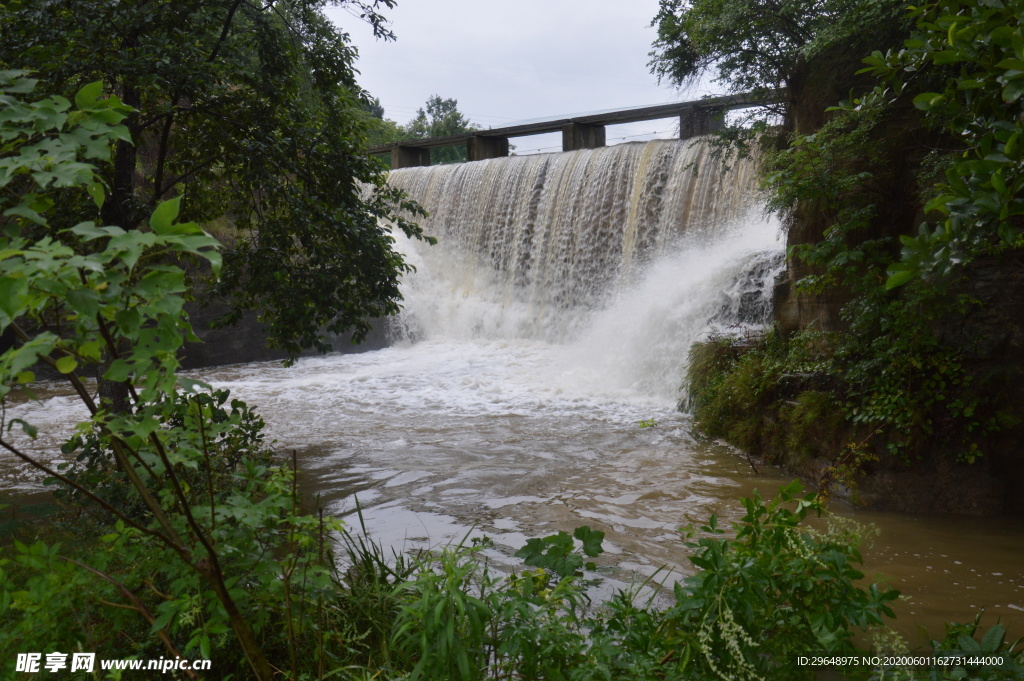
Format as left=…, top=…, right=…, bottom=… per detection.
left=688, top=332, right=1024, bottom=517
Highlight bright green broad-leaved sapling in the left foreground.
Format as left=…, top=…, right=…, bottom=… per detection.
left=0, top=71, right=287, bottom=680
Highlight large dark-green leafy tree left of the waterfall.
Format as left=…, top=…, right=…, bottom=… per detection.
left=0, top=0, right=430, bottom=354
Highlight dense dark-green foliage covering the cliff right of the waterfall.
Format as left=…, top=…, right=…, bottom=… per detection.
left=690, top=0, right=1024, bottom=475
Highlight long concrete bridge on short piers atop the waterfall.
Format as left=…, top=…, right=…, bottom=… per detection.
left=370, top=93, right=779, bottom=168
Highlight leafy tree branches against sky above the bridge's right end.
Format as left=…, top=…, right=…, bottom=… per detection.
left=650, top=0, right=906, bottom=130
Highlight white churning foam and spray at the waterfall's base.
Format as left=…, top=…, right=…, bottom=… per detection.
left=387, top=213, right=781, bottom=403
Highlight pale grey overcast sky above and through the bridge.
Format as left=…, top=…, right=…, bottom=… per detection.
left=328, top=0, right=707, bottom=153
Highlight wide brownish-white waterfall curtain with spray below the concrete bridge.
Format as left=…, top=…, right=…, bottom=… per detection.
left=389, top=140, right=781, bottom=397
